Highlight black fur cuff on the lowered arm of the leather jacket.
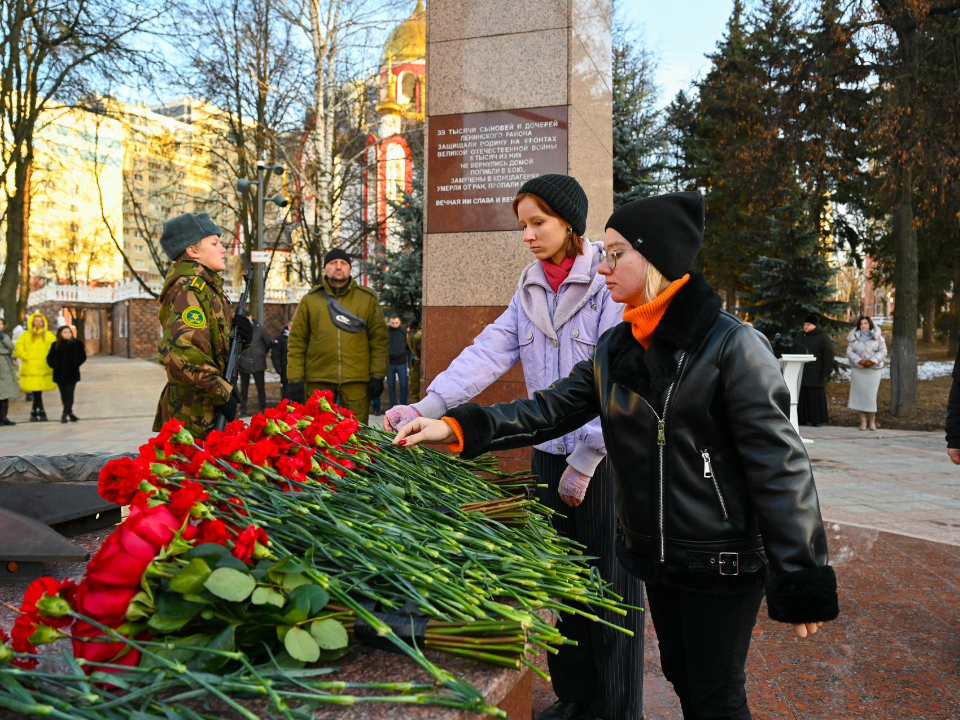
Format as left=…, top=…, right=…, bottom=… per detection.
left=767, top=565, right=840, bottom=625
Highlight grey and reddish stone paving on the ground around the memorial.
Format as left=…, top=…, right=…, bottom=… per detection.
left=0, top=357, right=960, bottom=720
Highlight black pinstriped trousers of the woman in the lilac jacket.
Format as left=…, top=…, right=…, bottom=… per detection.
left=532, top=450, right=643, bottom=720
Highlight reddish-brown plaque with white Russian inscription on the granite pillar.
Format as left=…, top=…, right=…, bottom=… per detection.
left=427, top=105, right=567, bottom=233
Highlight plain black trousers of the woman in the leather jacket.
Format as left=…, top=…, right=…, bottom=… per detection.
left=647, top=585, right=763, bottom=720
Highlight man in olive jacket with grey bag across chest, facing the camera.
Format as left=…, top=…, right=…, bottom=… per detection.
left=287, top=248, right=387, bottom=423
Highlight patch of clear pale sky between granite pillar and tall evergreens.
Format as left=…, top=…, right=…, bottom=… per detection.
left=621, top=0, right=733, bottom=105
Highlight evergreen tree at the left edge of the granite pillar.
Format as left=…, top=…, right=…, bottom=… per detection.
left=365, top=162, right=423, bottom=323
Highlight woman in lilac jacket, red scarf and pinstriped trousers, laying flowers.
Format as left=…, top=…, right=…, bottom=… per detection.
left=384, top=175, right=643, bottom=720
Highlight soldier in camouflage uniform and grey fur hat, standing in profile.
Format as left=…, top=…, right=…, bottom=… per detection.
left=153, top=213, right=252, bottom=437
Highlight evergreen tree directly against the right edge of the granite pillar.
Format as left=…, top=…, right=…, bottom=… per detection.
left=613, top=22, right=667, bottom=207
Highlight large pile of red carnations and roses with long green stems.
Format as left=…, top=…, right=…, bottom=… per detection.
left=0, top=393, right=626, bottom=712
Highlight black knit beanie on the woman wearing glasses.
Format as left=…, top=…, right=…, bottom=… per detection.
left=607, top=192, right=704, bottom=280
